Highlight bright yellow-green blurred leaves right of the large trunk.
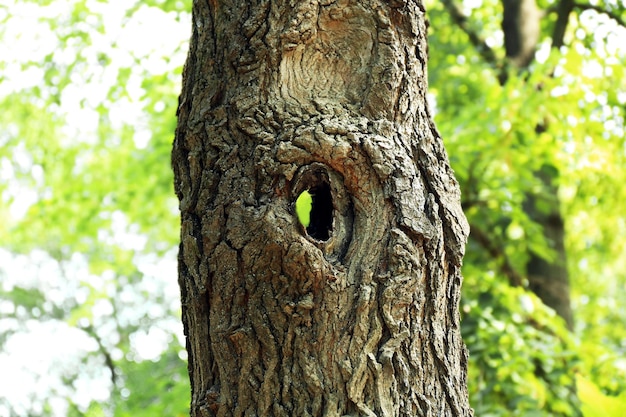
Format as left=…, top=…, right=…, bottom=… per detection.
left=427, top=1, right=626, bottom=416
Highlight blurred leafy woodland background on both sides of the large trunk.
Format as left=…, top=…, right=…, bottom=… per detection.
left=0, top=0, right=626, bottom=417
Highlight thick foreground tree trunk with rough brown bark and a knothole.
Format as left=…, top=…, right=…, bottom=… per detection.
left=172, top=0, right=472, bottom=417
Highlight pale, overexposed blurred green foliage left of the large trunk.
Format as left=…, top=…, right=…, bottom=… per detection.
left=0, top=0, right=190, bottom=416
